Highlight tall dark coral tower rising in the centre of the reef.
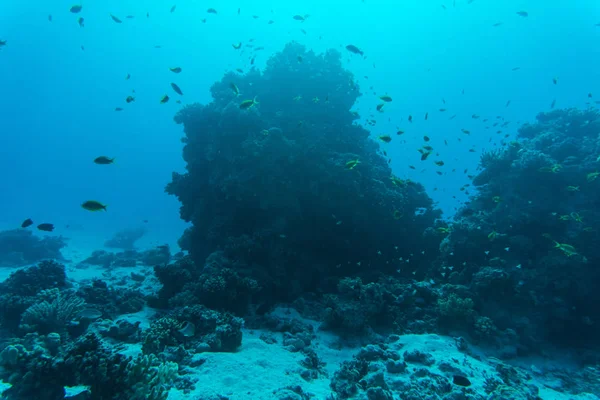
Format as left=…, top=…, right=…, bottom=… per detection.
left=167, top=43, right=440, bottom=312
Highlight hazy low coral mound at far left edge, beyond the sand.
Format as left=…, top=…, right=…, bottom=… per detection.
left=0, top=229, right=67, bottom=266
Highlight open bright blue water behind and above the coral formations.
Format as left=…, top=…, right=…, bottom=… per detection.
left=0, top=0, right=600, bottom=245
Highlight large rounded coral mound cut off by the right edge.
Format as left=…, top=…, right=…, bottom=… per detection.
left=432, top=109, right=600, bottom=350
